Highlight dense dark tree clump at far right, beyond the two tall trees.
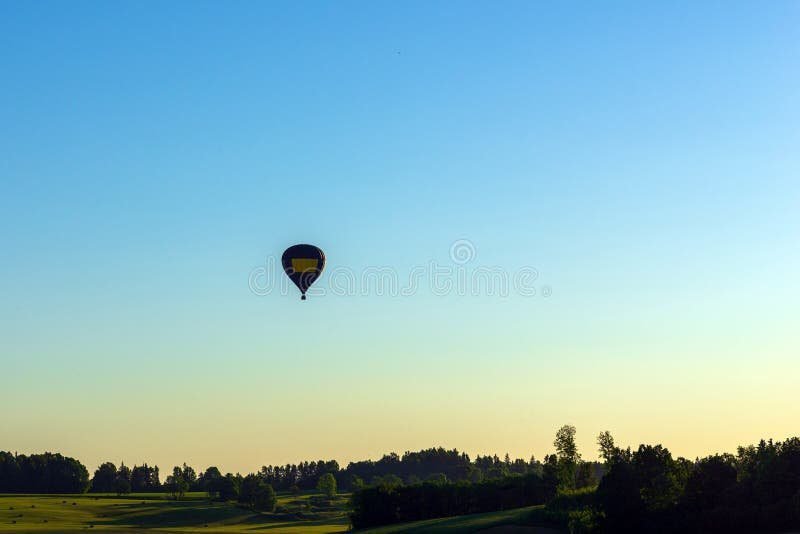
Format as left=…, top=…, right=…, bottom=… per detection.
left=583, top=435, right=800, bottom=533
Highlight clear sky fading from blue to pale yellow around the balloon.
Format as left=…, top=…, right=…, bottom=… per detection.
left=0, top=2, right=800, bottom=472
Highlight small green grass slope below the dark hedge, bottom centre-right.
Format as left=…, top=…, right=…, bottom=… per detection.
left=362, top=506, right=558, bottom=534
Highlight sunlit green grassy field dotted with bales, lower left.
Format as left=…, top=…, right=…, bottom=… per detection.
left=0, top=493, right=349, bottom=534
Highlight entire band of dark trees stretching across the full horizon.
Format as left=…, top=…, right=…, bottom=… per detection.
left=0, top=425, right=800, bottom=533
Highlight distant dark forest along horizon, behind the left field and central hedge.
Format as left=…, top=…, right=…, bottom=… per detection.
left=0, top=447, right=576, bottom=496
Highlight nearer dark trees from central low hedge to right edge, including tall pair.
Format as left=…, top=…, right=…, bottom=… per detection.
left=351, top=425, right=800, bottom=534
